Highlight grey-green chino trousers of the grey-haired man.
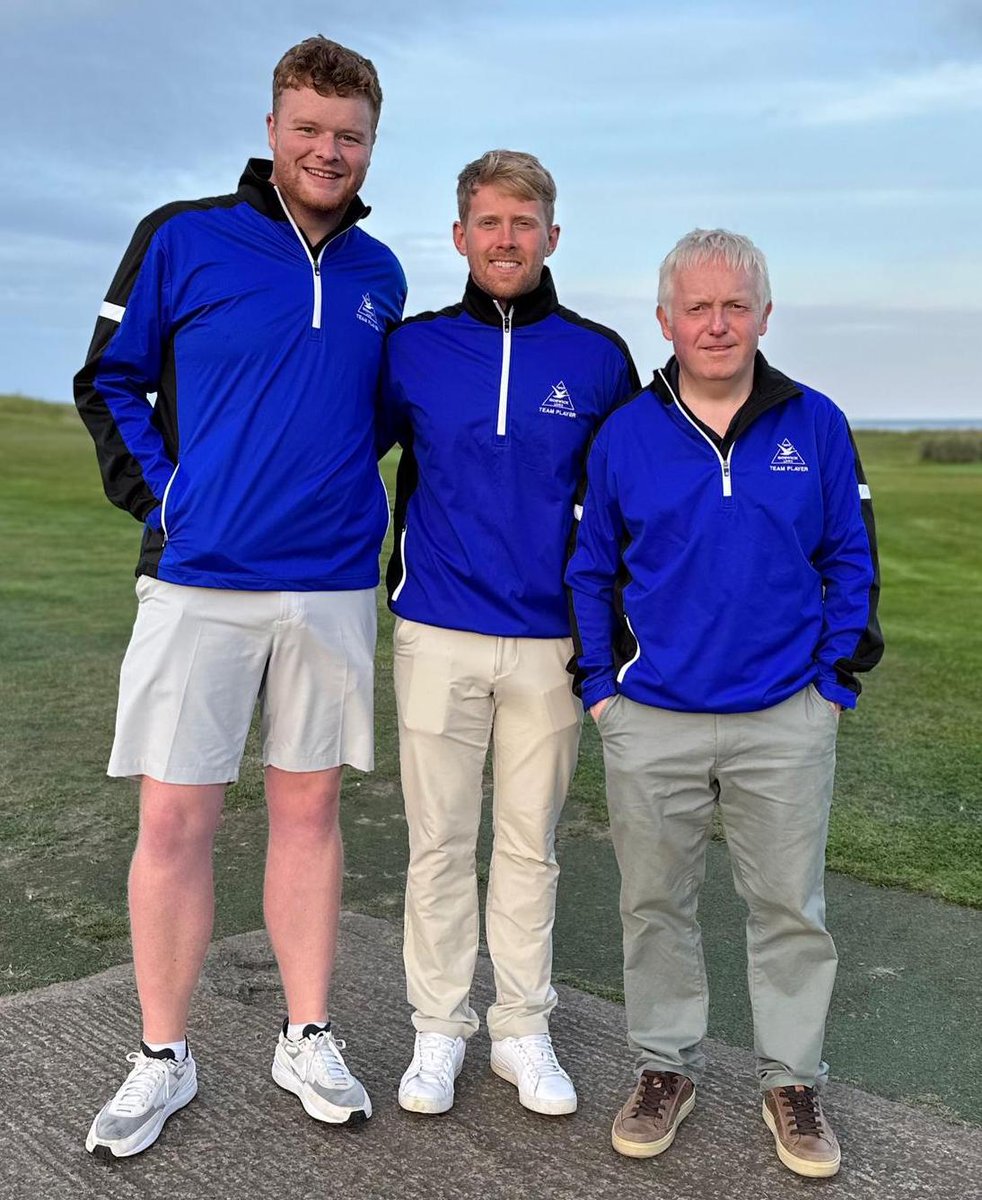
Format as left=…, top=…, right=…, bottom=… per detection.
left=599, top=685, right=838, bottom=1091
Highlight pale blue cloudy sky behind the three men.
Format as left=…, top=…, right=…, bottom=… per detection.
left=0, top=0, right=982, bottom=419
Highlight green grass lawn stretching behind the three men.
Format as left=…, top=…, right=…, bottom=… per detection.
left=0, top=397, right=982, bottom=991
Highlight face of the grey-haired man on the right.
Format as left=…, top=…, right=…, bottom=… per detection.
left=658, top=259, right=771, bottom=389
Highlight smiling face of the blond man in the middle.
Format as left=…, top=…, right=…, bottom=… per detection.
left=454, top=184, right=559, bottom=304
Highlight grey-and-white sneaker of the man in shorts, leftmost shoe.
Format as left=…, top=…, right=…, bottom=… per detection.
left=85, top=1049, right=198, bottom=1159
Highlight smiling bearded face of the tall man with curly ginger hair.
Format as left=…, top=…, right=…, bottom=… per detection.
left=267, top=88, right=375, bottom=242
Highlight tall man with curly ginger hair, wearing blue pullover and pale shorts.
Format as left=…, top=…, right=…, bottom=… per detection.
left=76, top=36, right=406, bottom=1158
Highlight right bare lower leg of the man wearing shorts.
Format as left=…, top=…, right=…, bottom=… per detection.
left=264, top=767, right=345, bottom=1024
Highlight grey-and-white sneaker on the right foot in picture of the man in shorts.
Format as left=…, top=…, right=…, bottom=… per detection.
left=273, top=1025, right=372, bottom=1124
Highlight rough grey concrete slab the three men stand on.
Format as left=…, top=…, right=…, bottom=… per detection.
left=0, top=914, right=982, bottom=1200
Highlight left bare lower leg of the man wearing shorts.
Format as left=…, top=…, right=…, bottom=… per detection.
left=130, top=775, right=224, bottom=1042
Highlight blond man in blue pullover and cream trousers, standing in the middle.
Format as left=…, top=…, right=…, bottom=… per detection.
left=383, top=150, right=636, bottom=1115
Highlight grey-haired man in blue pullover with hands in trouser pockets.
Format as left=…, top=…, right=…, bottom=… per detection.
left=567, top=229, right=882, bottom=1176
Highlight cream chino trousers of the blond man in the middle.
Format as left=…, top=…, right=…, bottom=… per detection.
left=394, top=619, right=582, bottom=1040
